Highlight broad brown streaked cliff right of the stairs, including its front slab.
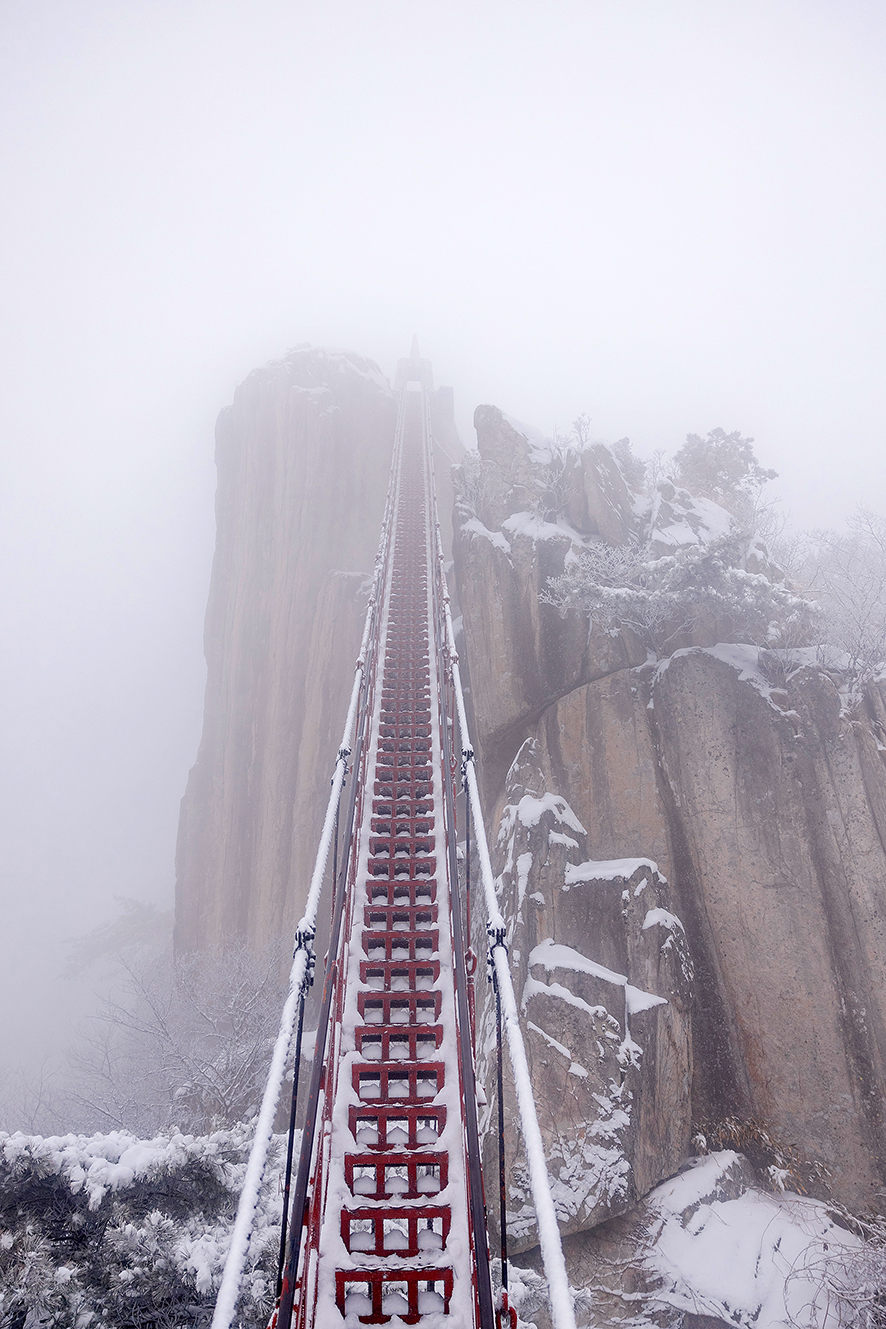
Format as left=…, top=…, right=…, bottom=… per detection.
left=453, top=408, right=886, bottom=1245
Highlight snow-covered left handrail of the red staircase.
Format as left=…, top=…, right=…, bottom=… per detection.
left=211, top=449, right=396, bottom=1329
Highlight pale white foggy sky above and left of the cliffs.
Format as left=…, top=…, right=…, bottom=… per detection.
left=0, top=0, right=886, bottom=1061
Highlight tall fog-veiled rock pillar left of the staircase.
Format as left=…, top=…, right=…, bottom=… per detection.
left=175, top=350, right=396, bottom=949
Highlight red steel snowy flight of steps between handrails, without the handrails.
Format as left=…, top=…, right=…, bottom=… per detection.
left=282, top=364, right=493, bottom=1326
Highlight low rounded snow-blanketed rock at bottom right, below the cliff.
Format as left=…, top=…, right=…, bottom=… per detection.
left=555, top=1151, right=871, bottom=1329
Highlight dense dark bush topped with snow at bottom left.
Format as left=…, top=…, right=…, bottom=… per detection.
left=0, top=1126, right=283, bottom=1329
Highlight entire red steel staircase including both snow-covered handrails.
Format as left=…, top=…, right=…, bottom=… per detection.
left=213, top=342, right=575, bottom=1329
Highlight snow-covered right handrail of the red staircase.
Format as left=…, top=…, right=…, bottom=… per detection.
left=430, top=443, right=575, bottom=1329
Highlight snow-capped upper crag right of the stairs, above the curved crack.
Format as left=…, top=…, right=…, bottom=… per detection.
left=453, top=407, right=646, bottom=787
